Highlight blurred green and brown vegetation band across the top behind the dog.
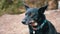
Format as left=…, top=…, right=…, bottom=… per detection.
left=0, top=0, right=60, bottom=15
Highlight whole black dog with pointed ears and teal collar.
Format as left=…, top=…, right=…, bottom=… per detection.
left=22, top=5, right=57, bottom=34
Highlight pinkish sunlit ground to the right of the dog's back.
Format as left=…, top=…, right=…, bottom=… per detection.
left=45, top=10, right=60, bottom=32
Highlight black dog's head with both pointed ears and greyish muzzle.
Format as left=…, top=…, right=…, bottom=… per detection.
left=22, top=5, right=48, bottom=25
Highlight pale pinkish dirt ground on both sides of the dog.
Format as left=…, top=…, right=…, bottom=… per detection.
left=0, top=10, right=60, bottom=34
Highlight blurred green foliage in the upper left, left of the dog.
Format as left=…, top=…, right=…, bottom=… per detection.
left=0, top=0, right=23, bottom=15
